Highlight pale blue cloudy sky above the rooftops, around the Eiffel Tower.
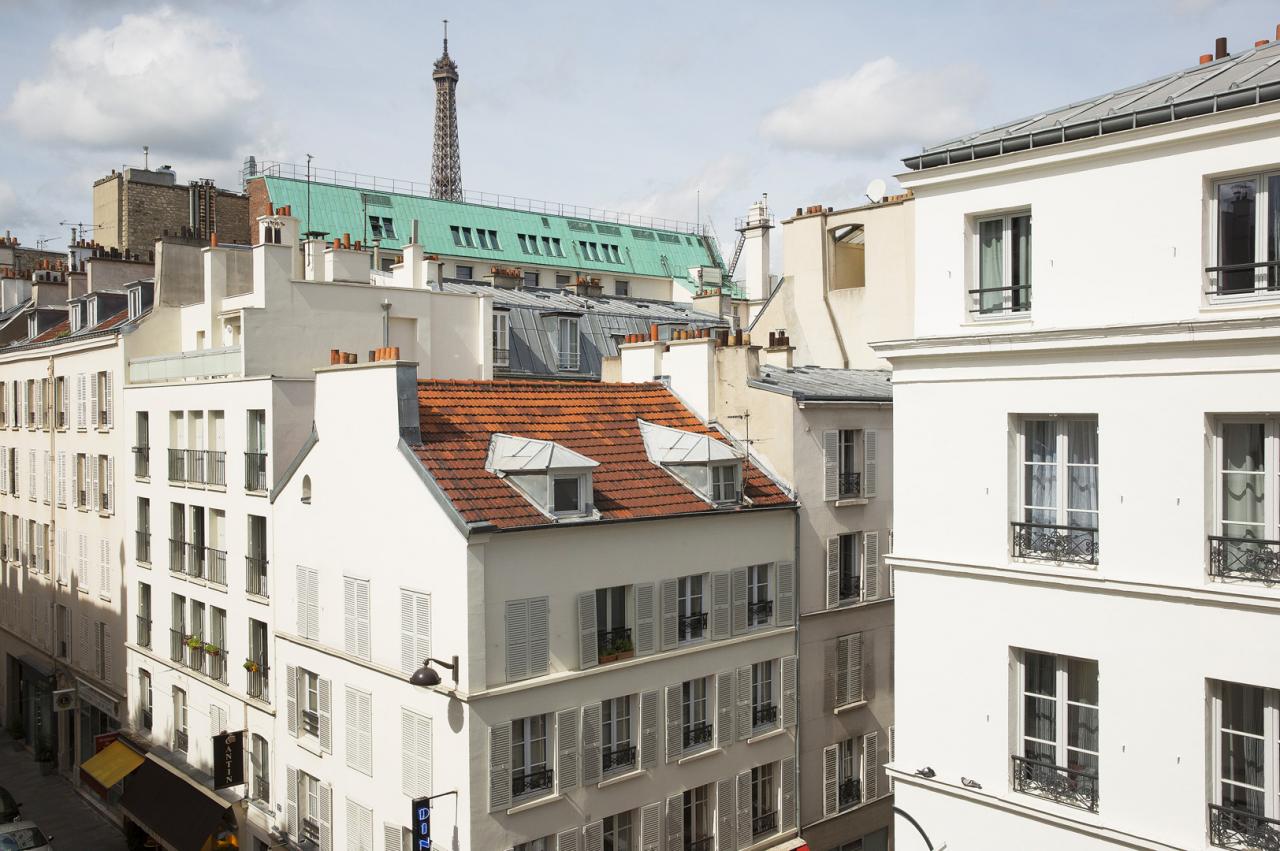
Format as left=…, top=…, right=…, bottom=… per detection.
left=0, top=0, right=1280, bottom=248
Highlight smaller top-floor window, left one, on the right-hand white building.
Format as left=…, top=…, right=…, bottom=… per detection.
left=969, top=212, right=1032, bottom=315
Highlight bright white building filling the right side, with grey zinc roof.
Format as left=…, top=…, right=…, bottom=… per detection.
left=876, top=36, right=1280, bottom=851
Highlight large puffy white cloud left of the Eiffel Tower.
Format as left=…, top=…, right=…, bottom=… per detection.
left=6, top=6, right=259, bottom=157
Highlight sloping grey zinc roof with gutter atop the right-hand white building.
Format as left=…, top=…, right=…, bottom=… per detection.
left=902, top=41, right=1280, bottom=169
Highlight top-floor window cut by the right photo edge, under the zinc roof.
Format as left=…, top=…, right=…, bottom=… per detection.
left=1204, top=174, right=1280, bottom=296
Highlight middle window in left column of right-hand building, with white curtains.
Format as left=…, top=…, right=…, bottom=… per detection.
left=1012, top=417, right=1098, bottom=564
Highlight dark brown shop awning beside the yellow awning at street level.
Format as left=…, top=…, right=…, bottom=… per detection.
left=120, top=754, right=234, bottom=851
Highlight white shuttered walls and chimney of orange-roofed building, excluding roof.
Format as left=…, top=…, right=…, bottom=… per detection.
left=274, top=363, right=799, bottom=851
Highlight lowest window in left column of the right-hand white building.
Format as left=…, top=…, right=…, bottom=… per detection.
left=1014, top=650, right=1098, bottom=811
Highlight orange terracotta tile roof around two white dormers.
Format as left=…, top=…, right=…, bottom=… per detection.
left=415, top=380, right=792, bottom=529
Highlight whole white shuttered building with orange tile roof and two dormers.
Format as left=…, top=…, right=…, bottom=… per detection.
left=273, top=371, right=803, bottom=851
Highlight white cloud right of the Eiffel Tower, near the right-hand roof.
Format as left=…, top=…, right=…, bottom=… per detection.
left=760, top=56, right=987, bottom=156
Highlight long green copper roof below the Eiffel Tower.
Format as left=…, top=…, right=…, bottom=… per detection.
left=253, top=175, right=724, bottom=290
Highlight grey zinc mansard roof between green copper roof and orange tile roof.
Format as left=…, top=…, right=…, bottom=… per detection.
left=443, top=280, right=728, bottom=380
